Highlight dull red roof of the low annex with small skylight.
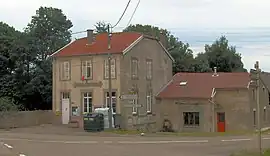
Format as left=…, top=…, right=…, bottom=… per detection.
left=157, top=72, right=250, bottom=98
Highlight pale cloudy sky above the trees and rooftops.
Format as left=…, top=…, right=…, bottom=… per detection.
left=0, top=0, right=270, bottom=71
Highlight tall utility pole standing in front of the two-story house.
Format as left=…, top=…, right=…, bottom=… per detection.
left=108, top=24, right=113, bottom=129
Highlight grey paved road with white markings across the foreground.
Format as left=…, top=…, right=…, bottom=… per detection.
left=0, top=133, right=270, bottom=156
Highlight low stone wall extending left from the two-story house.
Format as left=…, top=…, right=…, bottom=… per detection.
left=0, top=110, right=61, bottom=129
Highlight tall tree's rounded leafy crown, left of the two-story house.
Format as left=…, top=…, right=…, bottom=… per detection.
left=25, top=7, right=73, bottom=61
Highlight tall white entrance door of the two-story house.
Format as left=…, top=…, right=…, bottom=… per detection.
left=61, top=93, right=70, bottom=124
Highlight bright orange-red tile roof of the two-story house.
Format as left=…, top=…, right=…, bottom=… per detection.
left=54, top=32, right=142, bottom=56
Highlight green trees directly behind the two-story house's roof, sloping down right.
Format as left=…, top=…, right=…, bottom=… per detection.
left=123, top=24, right=194, bottom=73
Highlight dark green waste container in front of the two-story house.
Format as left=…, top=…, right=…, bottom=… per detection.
left=83, top=113, right=104, bottom=132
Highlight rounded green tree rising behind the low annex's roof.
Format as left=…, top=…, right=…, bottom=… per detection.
left=205, top=36, right=247, bottom=72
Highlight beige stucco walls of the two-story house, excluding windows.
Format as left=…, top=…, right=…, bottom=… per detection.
left=53, top=37, right=172, bottom=129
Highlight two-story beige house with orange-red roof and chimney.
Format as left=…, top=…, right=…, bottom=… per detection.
left=52, top=30, right=173, bottom=129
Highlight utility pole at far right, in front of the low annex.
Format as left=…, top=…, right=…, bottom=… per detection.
left=254, top=61, right=262, bottom=155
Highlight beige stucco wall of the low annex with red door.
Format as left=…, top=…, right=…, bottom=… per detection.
left=157, top=85, right=270, bottom=132
